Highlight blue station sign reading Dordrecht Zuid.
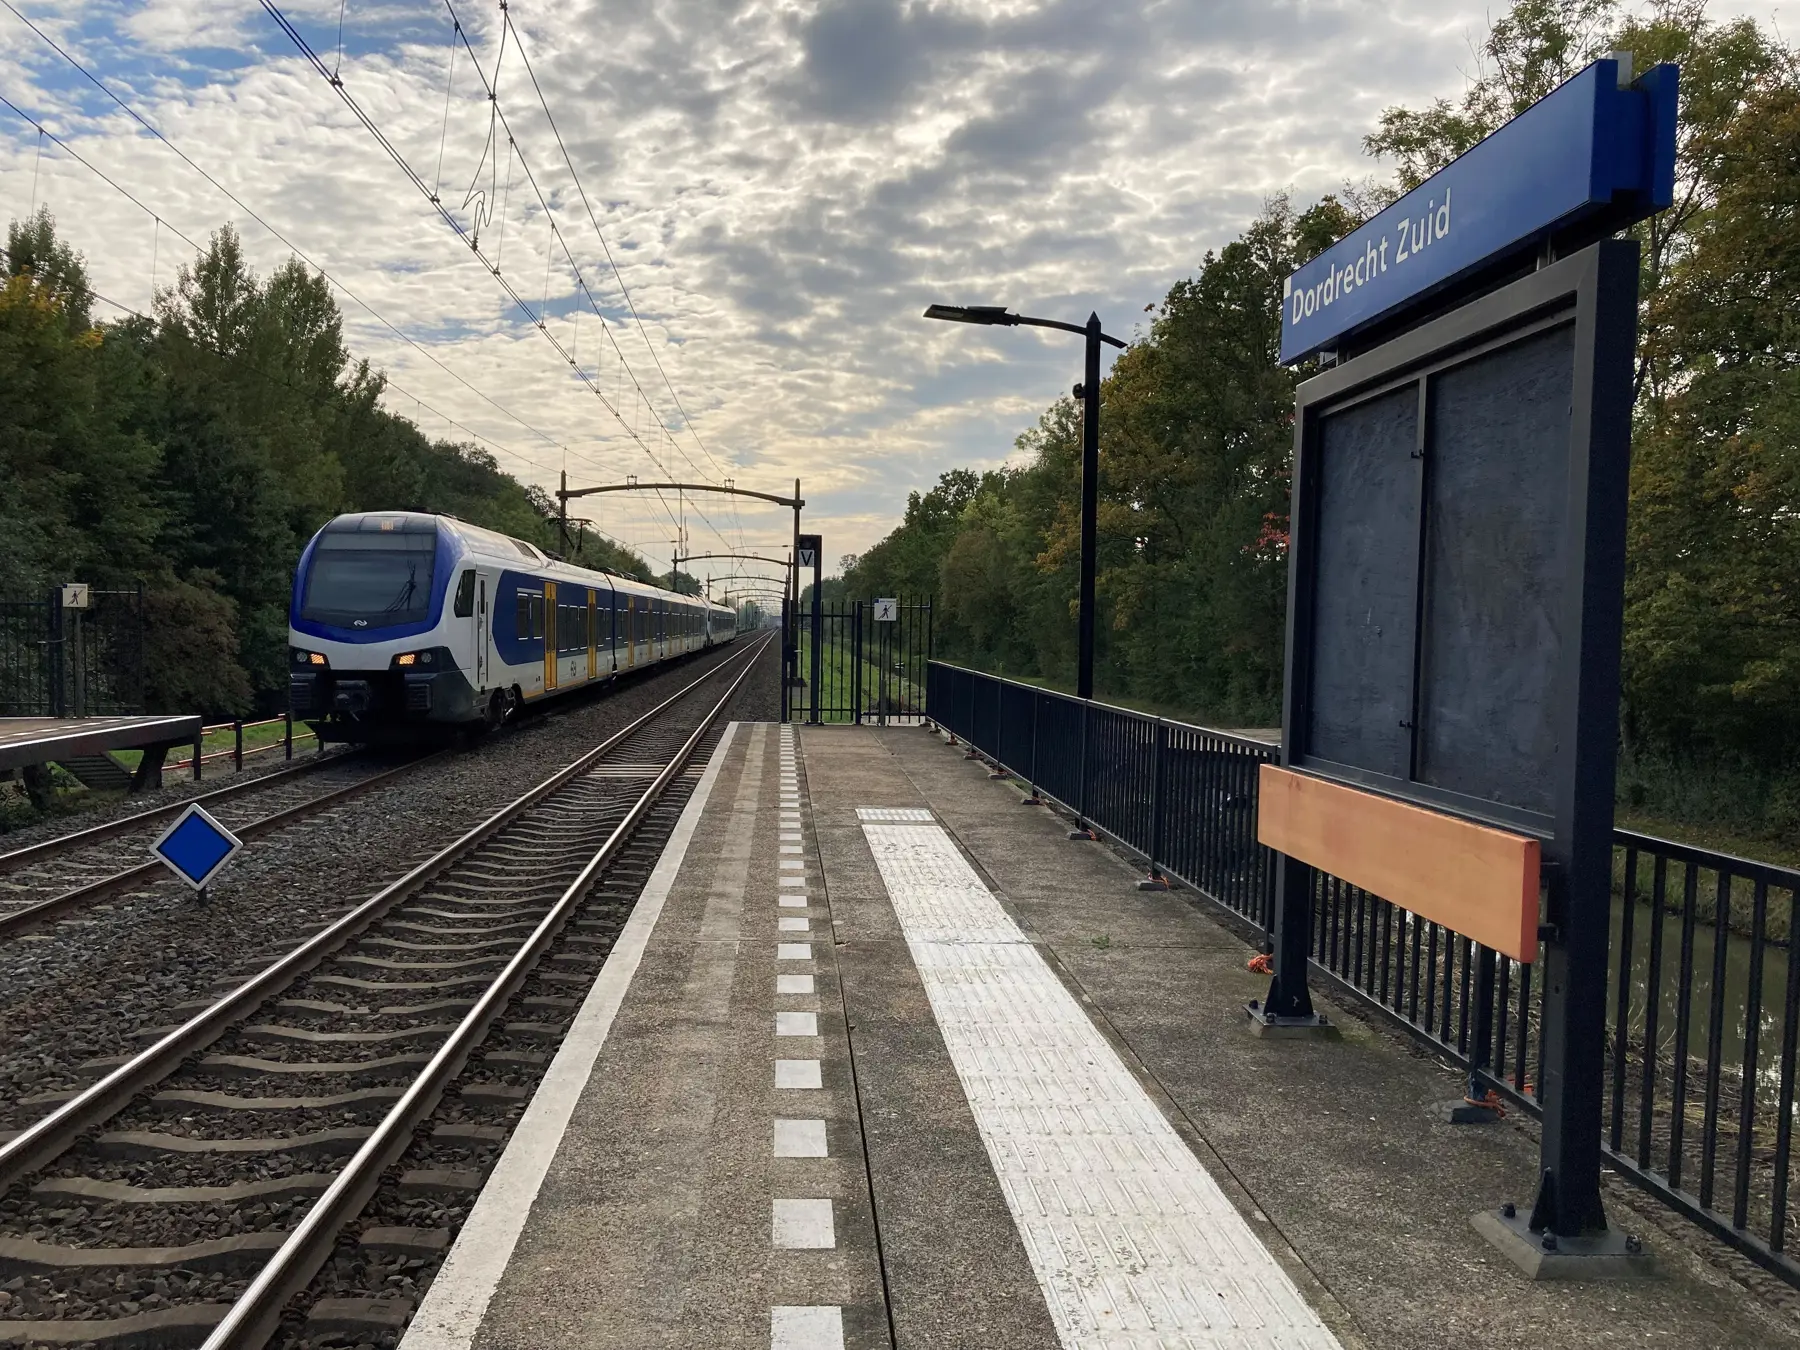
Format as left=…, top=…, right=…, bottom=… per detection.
left=1282, top=56, right=1678, bottom=365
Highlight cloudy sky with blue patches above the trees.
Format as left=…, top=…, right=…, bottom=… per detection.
left=0, top=0, right=1793, bottom=590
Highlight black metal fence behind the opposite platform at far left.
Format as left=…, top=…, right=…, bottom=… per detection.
left=0, top=589, right=144, bottom=716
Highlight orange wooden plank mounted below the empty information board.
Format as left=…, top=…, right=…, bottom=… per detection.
left=1256, top=763, right=1541, bottom=961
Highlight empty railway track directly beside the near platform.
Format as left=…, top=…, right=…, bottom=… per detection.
left=0, top=641, right=767, bottom=1350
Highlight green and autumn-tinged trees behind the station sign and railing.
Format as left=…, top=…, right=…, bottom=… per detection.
left=846, top=0, right=1800, bottom=781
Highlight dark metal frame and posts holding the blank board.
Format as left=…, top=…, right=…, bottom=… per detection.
left=1264, top=239, right=1638, bottom=1235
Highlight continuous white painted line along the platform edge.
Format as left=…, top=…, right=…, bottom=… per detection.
left=400, top=722, right=742, bottom=1350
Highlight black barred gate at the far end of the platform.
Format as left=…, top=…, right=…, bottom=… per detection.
left=806, top=598, right=931, bottom=725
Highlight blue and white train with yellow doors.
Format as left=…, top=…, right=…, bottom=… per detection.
left=288, top=511, right=736, bottom=742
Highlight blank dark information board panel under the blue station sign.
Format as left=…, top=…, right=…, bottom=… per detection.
left=1285, top=243, right=1634, bottom=837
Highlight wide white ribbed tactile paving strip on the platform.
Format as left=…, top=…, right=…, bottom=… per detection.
left=859, top=810, right=1337, bottom=1350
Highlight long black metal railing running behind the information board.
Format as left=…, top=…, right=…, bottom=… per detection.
left=927, top=661, right=1800, bottom=1283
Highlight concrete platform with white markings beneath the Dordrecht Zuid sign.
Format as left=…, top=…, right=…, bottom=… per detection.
left=401, top=724, right=1800, bottom=1350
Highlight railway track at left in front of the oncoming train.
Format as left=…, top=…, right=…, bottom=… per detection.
left=0, top=752, right=432, bottom=938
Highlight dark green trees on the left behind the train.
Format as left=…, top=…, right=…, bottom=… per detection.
left=0, top=211, right=650, bottom=716
